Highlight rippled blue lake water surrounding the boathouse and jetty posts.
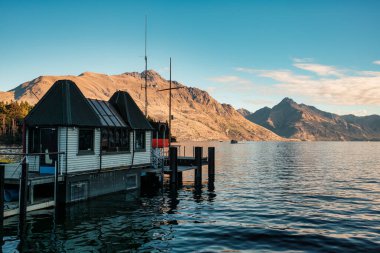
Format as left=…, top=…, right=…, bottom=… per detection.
left=3, top=142, right=380, bottom=252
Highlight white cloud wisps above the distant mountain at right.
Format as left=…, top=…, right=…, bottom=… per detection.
left=235, top=62, right=380, bottom=105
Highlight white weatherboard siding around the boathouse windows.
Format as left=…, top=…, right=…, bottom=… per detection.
left=58, top=127, right=152, bottom=173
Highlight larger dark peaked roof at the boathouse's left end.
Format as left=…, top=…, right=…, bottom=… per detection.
left=25, top=80, right=102, bottom=127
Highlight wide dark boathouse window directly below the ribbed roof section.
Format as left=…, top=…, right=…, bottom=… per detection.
left=102, top=128, right=130, bottom=152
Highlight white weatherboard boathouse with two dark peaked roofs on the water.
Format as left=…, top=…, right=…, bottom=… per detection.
left=25, top=80, right=153, bottom=203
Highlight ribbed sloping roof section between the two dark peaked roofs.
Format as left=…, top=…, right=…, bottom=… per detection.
left=87, top=98, right=128, bottom=127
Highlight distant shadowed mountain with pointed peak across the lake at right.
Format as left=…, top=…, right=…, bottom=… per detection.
left=245, top=98, right=380, bottom=141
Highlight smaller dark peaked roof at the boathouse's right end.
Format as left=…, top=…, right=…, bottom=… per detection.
left=109, top=91, right=153, bottom=130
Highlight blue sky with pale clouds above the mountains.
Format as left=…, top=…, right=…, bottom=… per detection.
left=0, top=0, right=380, bottom=115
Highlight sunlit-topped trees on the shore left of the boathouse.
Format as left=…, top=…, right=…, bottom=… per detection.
left=0, top=101, right=33, bottom=145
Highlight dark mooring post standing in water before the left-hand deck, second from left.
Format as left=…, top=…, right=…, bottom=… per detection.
left=19, top=160, right=28, bottom=236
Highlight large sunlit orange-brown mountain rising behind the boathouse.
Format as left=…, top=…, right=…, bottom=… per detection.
left=0, top=70, right=283, bottom=140
